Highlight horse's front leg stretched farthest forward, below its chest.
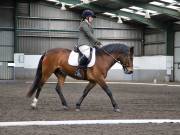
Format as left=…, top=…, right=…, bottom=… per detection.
left=98, top=79, right=120, bottom=112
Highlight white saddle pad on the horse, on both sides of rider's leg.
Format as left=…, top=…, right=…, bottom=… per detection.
left=68, top=48, right=96, bottom=67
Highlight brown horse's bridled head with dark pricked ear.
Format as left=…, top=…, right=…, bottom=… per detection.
left=119, top=47, right=134, bottom=74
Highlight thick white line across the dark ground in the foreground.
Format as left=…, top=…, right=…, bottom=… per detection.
left=0, top=119, right=180, bottom=127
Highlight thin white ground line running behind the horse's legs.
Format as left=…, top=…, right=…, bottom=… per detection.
left=26, top=81, right=180, bottom=87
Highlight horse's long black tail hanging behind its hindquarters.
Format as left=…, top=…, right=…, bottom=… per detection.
left=27, top=53, right=46, bottom=97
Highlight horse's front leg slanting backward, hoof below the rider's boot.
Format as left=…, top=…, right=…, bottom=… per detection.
left=76, top=82, right=96, bottom=111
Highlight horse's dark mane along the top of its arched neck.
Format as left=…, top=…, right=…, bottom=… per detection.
left=96, top=43, right=129, bottom=55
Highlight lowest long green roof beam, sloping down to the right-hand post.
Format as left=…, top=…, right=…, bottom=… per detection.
left=60, top=0, right=166, bottom=29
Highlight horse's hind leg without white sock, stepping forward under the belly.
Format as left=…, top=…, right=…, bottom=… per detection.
left=55, top=71, right=68, bottom=110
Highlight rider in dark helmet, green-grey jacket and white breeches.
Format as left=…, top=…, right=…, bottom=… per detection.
left=75, top=10, right=101, bottom=78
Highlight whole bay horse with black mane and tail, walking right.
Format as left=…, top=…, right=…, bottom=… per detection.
left=27, top=43, right=134, bottom=112
